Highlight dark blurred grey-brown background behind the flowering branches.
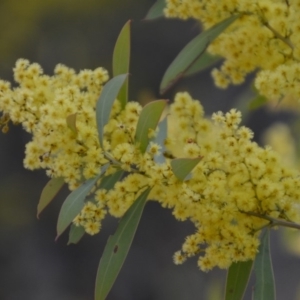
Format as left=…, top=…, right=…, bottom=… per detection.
left=0, top=0, right=300, bottom=300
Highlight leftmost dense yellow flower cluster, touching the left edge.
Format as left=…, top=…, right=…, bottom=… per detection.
left=0, top=59, right=108, bottom=189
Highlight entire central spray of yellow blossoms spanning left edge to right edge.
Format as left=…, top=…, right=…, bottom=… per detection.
left=0, top=60, right=300, bottom=271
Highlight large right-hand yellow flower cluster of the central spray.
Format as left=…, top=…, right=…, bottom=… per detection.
left=160, top=93, right=300, bottom=271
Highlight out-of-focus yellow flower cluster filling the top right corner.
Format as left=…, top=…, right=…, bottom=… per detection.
left=164, top=0, right=300, bottom=99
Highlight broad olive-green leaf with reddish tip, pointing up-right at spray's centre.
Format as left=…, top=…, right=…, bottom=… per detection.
left=135, top=100, right=167, bottom=153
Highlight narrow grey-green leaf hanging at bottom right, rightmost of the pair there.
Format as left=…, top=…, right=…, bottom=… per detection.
left=253, top=230, right=276, bottom=300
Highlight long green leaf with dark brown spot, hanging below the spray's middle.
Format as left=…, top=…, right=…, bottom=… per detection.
left=95, top=188, right=150, bottom=300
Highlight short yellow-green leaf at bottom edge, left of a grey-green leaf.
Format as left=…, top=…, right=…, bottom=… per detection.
left=225, top=260, right=253, bottom=300
